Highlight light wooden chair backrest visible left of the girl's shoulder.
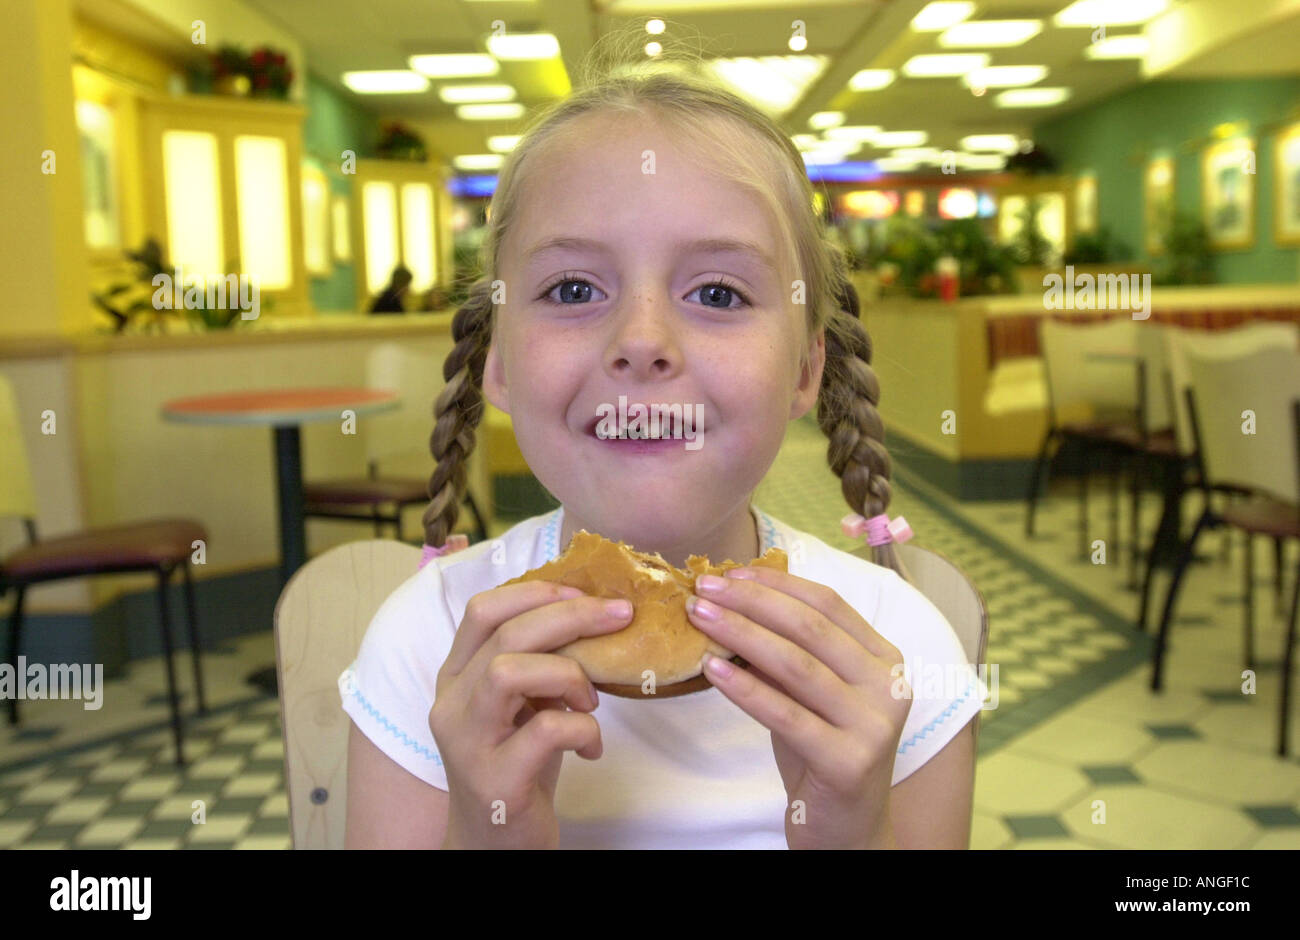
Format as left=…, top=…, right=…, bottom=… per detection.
left=274, top=540, right=420, bottom=849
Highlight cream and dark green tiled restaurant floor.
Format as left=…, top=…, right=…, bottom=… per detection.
left=0, top=423, right=1300, bottom=849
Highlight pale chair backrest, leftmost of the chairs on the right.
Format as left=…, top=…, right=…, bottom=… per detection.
left=1039, top=316, right=1138, bottom=424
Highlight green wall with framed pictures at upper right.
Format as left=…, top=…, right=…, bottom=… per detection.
left=1034, top=77, right=1300, bottom=283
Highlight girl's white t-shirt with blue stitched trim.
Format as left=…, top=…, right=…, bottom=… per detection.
left=339, top=507, right=988, bottom=849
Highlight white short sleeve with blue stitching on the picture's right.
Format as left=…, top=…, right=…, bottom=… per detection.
left=872, top=572, right=988, bottom=785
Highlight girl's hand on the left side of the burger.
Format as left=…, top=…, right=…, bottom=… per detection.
left=429, top=581, right=632, bottom=848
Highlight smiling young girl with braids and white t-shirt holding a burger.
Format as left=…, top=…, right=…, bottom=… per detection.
left=339, top=44, right=985, bottom=849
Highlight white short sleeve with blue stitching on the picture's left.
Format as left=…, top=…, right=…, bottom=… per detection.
left=338, top=564, right=455, bottom=790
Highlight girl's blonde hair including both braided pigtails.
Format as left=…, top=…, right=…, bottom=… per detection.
left=423, top=29, right=907, bottom=577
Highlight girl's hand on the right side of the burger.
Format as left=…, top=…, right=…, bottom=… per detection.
left=686, top=568, right=911, bottom=849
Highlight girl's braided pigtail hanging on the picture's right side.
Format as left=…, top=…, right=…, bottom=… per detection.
left=818, top=277, right=910, bottom=580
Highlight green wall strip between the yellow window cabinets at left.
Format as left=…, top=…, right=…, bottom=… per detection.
left=303, top=75, right=378, bottom=311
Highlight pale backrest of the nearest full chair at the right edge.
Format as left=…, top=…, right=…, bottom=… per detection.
left=1187, top=347, right=1300, bottom=506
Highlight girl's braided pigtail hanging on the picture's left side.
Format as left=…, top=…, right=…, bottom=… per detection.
left=421, top=277, right=493, bottom=546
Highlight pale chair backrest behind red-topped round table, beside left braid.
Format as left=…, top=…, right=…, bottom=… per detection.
left=364, top=343, right=446, bottom=463
